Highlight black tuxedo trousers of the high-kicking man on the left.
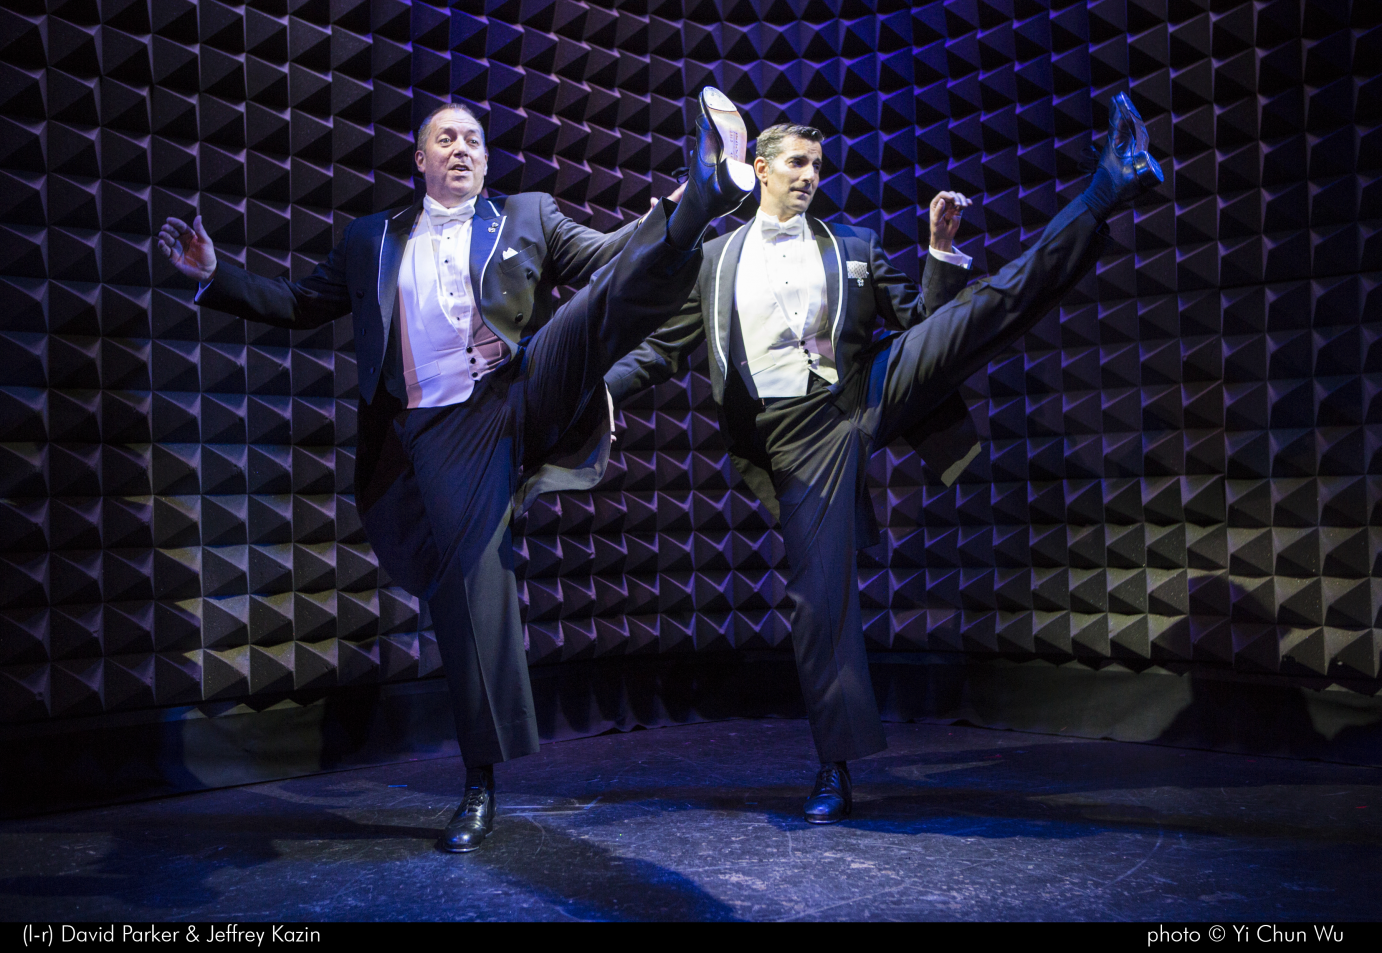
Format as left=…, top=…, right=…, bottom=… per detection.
left=392, top=206, right=701, bottom=765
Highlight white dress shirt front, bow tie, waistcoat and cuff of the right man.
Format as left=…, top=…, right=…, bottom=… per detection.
left=730, top=209, right=972, bottom=399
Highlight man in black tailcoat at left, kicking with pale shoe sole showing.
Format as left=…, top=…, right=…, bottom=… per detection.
left=159, top=88, right=752, bottom=852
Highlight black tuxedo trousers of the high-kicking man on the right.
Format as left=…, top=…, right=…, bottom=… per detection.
left=755, top=199, right=1104, bottom=761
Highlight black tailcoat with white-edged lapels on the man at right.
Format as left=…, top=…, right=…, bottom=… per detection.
left=605, top=215, right=974, bottom=515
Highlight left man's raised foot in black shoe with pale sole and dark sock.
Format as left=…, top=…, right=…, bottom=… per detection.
left=668, top=86, right=757, bottom=251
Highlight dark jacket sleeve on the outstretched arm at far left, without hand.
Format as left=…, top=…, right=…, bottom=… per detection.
left=196, top=228, right=351, bottom=330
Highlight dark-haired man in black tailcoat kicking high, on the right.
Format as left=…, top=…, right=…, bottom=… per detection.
left=605, top=94, right=1161, bottom=823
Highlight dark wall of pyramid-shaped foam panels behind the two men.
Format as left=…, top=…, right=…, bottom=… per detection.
left=0, top=0, right=1382, bottom=721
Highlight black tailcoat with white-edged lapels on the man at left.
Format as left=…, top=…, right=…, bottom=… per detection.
left=199, top=192, right=637, bottom=593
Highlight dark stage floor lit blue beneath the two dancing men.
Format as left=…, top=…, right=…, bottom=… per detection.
left=0, top=721, right=1382, bottom=924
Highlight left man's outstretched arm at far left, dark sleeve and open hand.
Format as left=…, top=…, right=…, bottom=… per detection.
left=158, top=215, right=351, bottom=330
